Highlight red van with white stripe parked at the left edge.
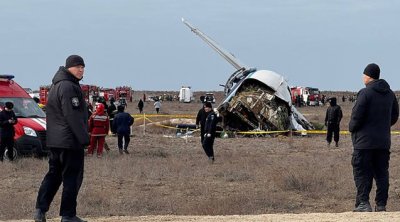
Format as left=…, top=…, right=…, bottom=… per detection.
left=0, top=75, right=48, bottom=158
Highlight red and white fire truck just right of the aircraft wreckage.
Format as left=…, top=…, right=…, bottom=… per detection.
left=290, top=86, right=321, bottom=106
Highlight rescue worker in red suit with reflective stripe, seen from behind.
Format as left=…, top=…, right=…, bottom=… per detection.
left=87, top=103, right=110, bottom=157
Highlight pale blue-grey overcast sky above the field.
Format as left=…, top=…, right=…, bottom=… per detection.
left=0, top=0, right=400, bottom=91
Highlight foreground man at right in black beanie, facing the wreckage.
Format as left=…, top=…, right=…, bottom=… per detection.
left=349, top=63, right=399, bottom=212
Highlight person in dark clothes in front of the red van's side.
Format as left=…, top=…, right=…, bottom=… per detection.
left=0, top=102, right=18, bottom=162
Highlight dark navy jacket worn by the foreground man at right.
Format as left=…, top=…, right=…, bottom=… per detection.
left=349, top=79, right=399, bottom=149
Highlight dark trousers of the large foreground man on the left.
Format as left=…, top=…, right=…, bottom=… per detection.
left=36, top=148, right=84, bottom=216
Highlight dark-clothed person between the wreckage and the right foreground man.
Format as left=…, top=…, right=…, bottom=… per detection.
left=325, top=97, right=343, bottom=147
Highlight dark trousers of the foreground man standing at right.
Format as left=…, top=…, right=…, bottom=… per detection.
left=351, top=149, right=390, bottom=207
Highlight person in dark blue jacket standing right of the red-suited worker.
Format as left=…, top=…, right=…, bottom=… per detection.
left=113, top=105, right=134, bottom=154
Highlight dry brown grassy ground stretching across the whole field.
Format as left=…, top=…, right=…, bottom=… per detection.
left=0, top=92, right=400, bottom=222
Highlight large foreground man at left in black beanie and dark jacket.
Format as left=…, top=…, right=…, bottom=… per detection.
left=34, top=55, right=89, bottom=222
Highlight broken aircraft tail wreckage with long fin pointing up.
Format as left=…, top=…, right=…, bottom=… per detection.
left=182, top=18, right=314, bottom=131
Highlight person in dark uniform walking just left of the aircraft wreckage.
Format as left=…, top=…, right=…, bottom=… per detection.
left=202, top=102, right=218, bottom=163
